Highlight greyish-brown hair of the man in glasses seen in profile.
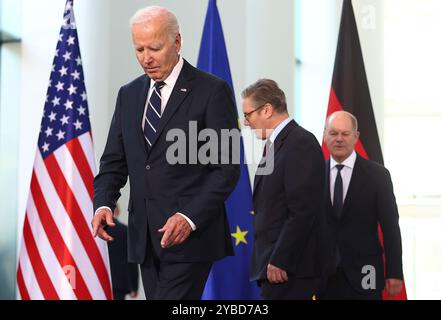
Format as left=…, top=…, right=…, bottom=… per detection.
left=242, top=79, right=288, bottom=113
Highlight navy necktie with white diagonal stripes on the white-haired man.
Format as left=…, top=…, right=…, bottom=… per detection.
left=144, top=81, right=165, bottom=149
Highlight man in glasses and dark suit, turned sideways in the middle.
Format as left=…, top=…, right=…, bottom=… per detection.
left=242, top=79, right=325, bottom=299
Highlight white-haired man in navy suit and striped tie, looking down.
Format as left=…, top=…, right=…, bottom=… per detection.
left=92, top=6, right=240, bottom=299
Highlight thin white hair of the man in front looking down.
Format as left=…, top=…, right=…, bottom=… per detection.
left=130, top=6, right=180, bottom=37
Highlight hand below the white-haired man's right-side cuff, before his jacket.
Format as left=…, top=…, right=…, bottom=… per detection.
left=158, top=213, right=192, bottom=248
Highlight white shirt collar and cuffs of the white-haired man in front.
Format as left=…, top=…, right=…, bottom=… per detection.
left=95, top=56, right=196, bottom=231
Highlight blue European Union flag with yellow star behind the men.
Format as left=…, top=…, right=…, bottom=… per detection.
left=198, top=0, right=259, bottom=300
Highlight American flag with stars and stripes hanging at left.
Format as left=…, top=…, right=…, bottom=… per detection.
left=17, top=0, right=112, bottom=300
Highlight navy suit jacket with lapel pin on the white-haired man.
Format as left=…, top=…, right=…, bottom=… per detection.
left=94, top=61, right=240, bottom=263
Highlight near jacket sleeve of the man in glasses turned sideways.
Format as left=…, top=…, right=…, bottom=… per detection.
left=270, top=134, right=325, bottom=272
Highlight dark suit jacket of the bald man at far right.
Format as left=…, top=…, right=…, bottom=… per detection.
left=325, top=154, right=403, bottom=292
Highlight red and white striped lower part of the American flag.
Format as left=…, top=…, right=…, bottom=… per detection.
left=17, top=132, right=112, bottom=299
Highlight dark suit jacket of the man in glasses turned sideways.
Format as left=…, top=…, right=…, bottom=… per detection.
left=251, top=121, right=325, bottom=280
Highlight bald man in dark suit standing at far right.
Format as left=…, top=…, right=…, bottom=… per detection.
left=320, top=111, right=403, bottom=300
